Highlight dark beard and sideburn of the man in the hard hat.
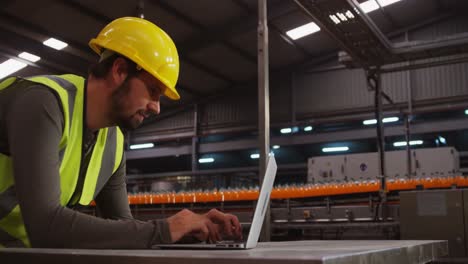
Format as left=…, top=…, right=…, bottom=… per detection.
left=110, top=78, right=145, bottom=130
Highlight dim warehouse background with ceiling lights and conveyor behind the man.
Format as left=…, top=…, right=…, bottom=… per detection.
left=0, top=0, right=468, bottom=263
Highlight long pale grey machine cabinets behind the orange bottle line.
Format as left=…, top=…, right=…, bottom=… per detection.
left=307, top=147, right=460, bottom=183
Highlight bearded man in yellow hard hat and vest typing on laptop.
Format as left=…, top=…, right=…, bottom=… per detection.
left=0, top=17, right=241, bottom=248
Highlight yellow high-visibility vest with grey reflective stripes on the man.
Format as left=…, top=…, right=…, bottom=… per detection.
left=0, top=74, right=124, bottom=247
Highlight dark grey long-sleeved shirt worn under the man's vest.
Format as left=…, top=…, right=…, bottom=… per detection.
left=0, top=78, right=171, bottom=248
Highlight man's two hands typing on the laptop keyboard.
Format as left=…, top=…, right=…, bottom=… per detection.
left=167, top=209, right=242, bottom=243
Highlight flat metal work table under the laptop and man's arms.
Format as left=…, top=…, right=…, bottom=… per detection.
left=0, top=240, right=448, bottom=264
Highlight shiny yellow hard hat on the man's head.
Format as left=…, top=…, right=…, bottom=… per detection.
left=89, top=17, right=180, bottom=100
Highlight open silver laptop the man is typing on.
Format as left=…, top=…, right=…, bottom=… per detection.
left=153, top=154, right=278, bottom=249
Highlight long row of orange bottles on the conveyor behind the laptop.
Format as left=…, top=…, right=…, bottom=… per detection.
left=117, top=176, right=468, bottom=204
